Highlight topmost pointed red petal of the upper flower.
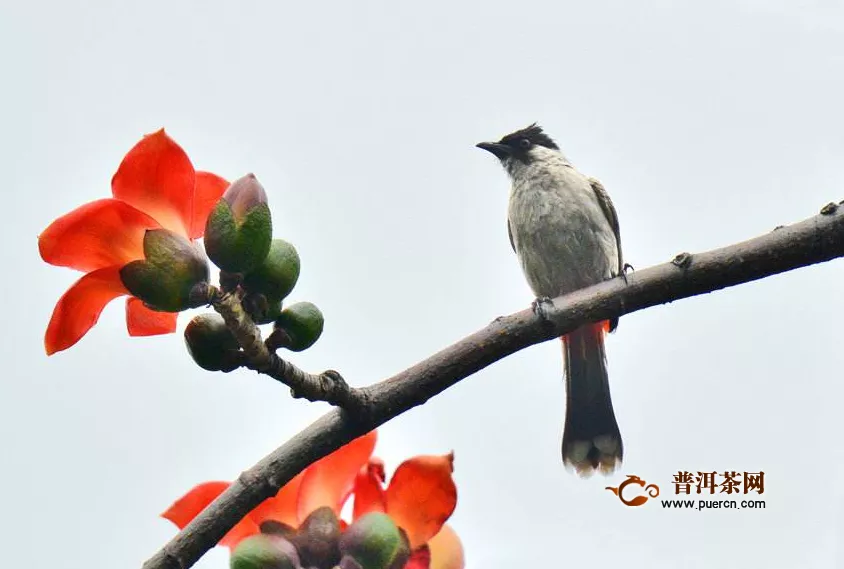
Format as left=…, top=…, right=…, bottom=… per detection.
left=111, top=129, right=196, bottom=235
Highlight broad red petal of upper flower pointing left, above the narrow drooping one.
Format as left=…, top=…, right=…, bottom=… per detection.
left=38, top=199, right=160, bottom=272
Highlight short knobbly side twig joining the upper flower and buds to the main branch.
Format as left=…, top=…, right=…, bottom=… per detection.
left=208, top=288, right=366, bottom=413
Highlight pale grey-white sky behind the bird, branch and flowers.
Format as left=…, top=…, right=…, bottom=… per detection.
left=0, top=0, right=844, bottom=569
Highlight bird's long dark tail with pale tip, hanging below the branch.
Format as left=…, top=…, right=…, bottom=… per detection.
left=561, top=322, right=623, bottom=475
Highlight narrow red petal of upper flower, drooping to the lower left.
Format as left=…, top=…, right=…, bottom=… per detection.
left=44, top=267, right=129, bottom=355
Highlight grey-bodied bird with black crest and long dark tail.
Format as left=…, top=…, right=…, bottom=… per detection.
left=477, top=124, right=625, bottom=475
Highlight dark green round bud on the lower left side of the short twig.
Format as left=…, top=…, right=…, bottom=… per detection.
left=185, top=312, right=240, bottom=372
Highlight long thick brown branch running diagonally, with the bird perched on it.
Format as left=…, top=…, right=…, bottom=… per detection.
left=144, top=204, right=844, bottom=569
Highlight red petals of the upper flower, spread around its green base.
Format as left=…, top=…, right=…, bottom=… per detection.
left=38, top=129, right=228, bottom=355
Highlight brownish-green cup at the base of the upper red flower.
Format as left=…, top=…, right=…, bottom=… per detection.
left=120, top=229, right=209, bottom=312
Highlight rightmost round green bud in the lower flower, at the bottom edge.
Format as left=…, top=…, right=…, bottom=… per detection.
left=340, top=512, right=410, bottom=569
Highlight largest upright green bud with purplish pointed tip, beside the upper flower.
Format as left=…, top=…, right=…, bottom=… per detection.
left=205, top=174, right=273, bottom=273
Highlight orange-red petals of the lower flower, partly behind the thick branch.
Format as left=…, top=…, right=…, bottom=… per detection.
left=162, top=431, right=463, bottom=569
